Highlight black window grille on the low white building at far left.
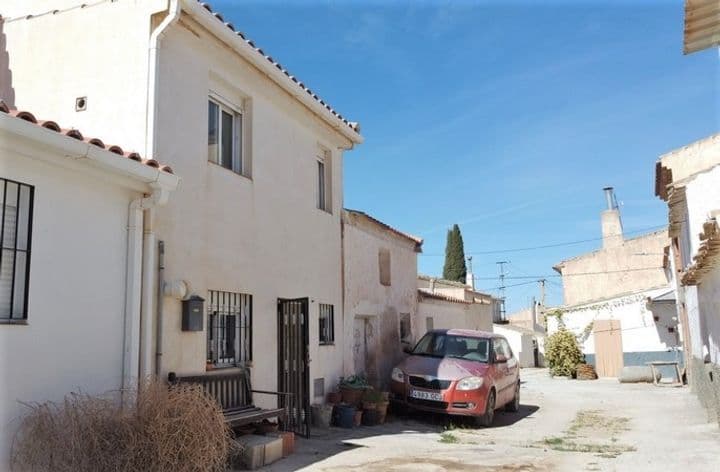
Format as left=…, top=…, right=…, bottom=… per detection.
left=0, top=178, right=35, bottom=322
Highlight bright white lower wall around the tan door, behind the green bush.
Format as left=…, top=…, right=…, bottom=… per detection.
left=547, top=288, right=679, bottom=354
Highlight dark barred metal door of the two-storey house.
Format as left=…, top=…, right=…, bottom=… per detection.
left=278, top=298, right=310, bottom=437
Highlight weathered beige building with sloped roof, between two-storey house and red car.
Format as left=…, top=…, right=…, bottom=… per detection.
left=343, top=210, right=422, bottom=388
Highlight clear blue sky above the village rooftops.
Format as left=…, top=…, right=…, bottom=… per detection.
left=211, top=0, right=720, bottom=312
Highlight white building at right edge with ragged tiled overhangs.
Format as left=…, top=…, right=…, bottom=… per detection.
left=655, top=134, right=720, bottom=421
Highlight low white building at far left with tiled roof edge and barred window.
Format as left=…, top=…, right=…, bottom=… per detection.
left=0, top=102, right=178, bottom=464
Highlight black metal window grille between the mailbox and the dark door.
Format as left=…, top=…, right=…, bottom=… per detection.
left=207, top=290, right=252, bottom=366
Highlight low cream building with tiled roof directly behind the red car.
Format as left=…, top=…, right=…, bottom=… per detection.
left=415, top=274, right=500, bottom=336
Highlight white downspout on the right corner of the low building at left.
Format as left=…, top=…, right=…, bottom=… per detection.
left=122, top=184, right=170, bottom=400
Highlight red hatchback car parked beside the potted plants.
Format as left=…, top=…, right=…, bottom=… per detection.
left=391, top=329, right=520, bottom=426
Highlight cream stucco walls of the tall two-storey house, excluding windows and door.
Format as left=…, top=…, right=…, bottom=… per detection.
left=0, top=0, right=360, bottom=405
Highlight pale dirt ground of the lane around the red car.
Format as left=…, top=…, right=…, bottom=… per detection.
left=263, top=369, right=720, bottom=472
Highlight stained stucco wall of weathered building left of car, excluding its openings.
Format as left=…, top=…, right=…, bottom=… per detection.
left=343, top=214, right=424, bottom=385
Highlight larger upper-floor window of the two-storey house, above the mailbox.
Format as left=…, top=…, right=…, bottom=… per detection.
left=208, top=98, right=250, bottom=176
